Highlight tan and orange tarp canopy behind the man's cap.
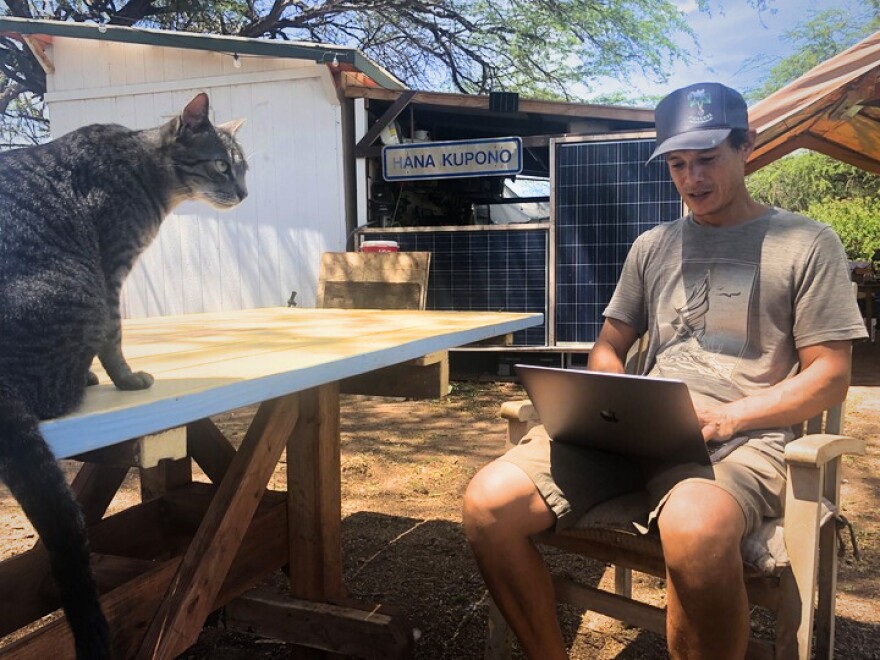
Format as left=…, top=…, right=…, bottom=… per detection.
left=747, top=32, right=880, bottom=174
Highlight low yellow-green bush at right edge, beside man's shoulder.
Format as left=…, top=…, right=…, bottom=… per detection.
left=806, top=197, right=880, bottom=261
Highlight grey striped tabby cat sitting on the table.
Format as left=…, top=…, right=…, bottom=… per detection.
left=0, top=93, right=247, bottom=660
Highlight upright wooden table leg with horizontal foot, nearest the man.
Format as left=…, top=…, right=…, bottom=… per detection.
left=226, top=384, right=414, bottom=660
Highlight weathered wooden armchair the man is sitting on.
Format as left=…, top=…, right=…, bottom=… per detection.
left=485, top=340, right=865, bottom=660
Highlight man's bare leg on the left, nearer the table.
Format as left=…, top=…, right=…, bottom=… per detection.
left=462, top=461, right=568, bottom=660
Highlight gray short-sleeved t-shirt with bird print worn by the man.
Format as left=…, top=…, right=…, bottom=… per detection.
left=604, top=209, right=867, bottom=402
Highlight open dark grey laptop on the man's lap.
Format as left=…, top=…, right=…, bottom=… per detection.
left=514, top=364, right=748, bottom=465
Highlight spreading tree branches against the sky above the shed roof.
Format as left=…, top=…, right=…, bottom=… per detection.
left=0, top=0, right=773, bottom=144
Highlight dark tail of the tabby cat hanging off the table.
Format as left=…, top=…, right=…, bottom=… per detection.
left=0, top=391, right=110, bottom=660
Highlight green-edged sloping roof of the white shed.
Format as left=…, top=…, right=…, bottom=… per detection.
left=0, top=16, right=406, bottom=89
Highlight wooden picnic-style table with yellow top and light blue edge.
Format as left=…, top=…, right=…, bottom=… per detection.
left=0, top=308, right=542, bottom=660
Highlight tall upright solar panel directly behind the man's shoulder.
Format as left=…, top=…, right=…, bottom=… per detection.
left=553, top=139, right=681, bottom=343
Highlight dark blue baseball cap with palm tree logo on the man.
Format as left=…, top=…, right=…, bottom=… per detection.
left=648, top=83, right=749, bottom=162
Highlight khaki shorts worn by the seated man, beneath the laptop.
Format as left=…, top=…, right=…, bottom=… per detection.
left=499, top=426, right=792, bottom=534
